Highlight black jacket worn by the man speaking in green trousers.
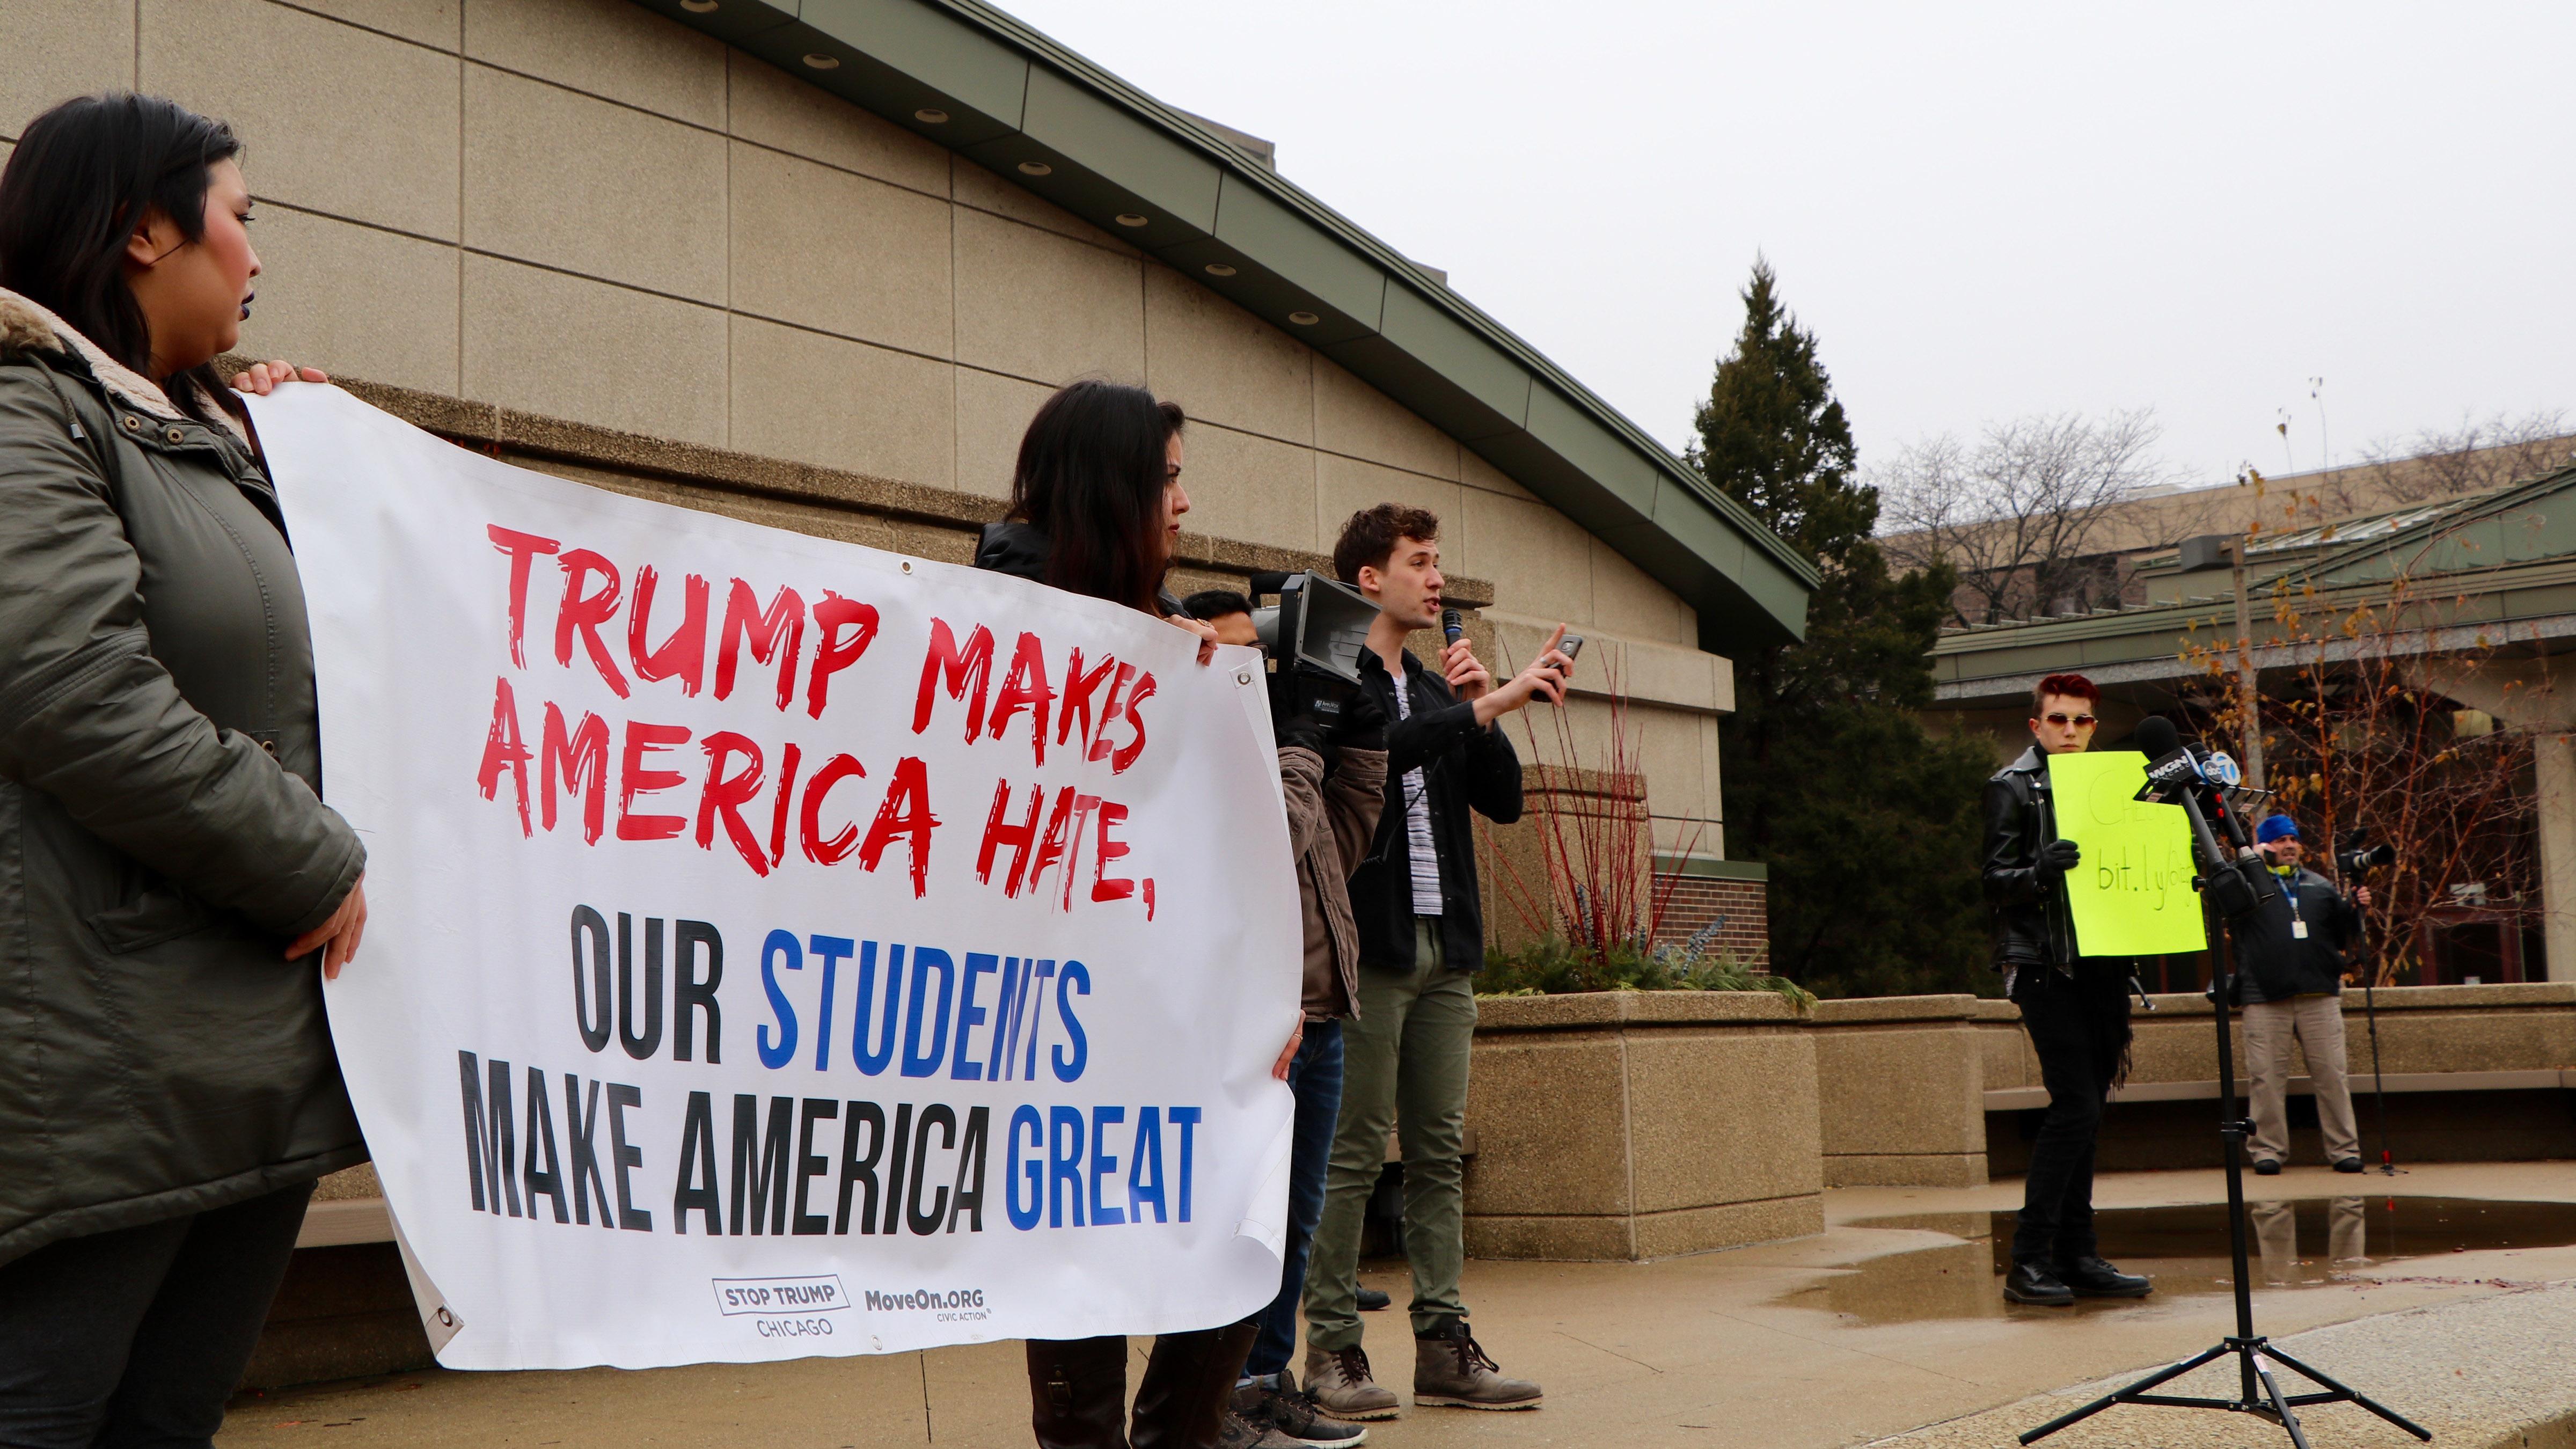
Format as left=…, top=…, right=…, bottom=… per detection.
left=1350, top=650, right=1520, bottom=972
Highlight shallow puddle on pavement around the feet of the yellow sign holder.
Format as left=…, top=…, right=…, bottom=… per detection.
left=1777, top=1196, right=2576, bottom=1325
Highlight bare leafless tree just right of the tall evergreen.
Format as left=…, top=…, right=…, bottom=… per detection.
left=1875, top=410, right=2174, bottom=624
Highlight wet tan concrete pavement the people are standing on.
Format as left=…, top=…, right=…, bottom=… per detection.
left=222, top=1163, right=2576, bottom=1449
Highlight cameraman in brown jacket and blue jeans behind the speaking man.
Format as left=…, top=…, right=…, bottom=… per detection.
left=1182, top=588, right=1386, bottom=1449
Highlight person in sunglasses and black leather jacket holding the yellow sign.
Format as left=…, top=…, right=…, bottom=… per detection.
left=1984, top=673, right=2154, bottom=1307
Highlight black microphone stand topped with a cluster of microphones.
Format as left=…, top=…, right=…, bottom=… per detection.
left=2022, top=784, right=2432, bottom=1449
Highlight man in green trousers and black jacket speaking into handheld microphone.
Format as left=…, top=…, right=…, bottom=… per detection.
left=1306, top=503, right=1574, bottom=1418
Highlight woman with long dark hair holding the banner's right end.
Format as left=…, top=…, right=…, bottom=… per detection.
left=974, top=382, right=1304, bottom=1449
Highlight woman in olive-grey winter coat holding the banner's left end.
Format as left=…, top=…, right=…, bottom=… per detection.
left=0, top=96, right=366, bottom=1446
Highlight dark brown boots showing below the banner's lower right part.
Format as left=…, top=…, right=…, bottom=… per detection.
left=1028, top=1323, right=1257, bottom=1449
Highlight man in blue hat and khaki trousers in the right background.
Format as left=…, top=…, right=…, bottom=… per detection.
left=2236, top=815, right=2370, bottom=1179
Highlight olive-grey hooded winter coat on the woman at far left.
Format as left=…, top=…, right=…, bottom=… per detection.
left=0, top=291, right=366, bottom=1263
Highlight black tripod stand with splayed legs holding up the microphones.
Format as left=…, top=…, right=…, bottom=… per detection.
left=2022, top=882, right=2432, bottom=1449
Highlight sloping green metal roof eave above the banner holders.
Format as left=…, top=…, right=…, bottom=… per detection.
left=636, top=0, right=1821, bottom=655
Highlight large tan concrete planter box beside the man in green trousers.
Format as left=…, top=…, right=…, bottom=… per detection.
left=1466, top=990, right=1824, bottom=1261
